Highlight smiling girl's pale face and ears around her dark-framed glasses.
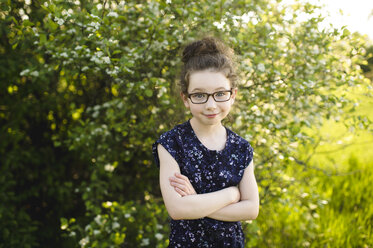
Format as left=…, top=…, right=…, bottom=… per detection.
left=181, top=70, right=237, bottom=125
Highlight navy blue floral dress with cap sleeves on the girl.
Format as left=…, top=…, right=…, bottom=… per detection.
left=152, top=121, right=253, bottom=247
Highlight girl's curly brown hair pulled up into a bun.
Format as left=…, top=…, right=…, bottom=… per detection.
left=180, top=37, right=237, bottom=94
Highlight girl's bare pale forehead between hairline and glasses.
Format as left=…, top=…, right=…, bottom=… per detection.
left=188, top=70, right=231, bottom=92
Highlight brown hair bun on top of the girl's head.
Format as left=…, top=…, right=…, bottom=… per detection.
left=181, top=37, right=230, bottom=63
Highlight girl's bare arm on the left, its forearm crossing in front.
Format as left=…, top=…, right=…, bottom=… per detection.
left=157, top=145, right=240, bottom=220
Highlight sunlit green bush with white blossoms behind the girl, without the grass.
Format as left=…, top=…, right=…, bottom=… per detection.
left=0, top=0, right=371, bottom=247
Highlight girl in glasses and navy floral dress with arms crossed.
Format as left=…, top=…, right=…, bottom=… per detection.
left=153, top=38, right=259, bottom=247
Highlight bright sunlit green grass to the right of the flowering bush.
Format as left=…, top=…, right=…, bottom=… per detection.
left=250, top=84, right=373, bottom=248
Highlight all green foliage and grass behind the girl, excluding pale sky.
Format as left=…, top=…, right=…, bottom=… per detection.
left=0, top=0, right=373, bottom=247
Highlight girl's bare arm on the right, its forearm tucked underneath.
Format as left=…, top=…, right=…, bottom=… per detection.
left=207, top=162, right=259, bottom=221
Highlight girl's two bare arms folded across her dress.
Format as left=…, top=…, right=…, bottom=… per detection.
left=158, top=144, right=259, bottom=221
